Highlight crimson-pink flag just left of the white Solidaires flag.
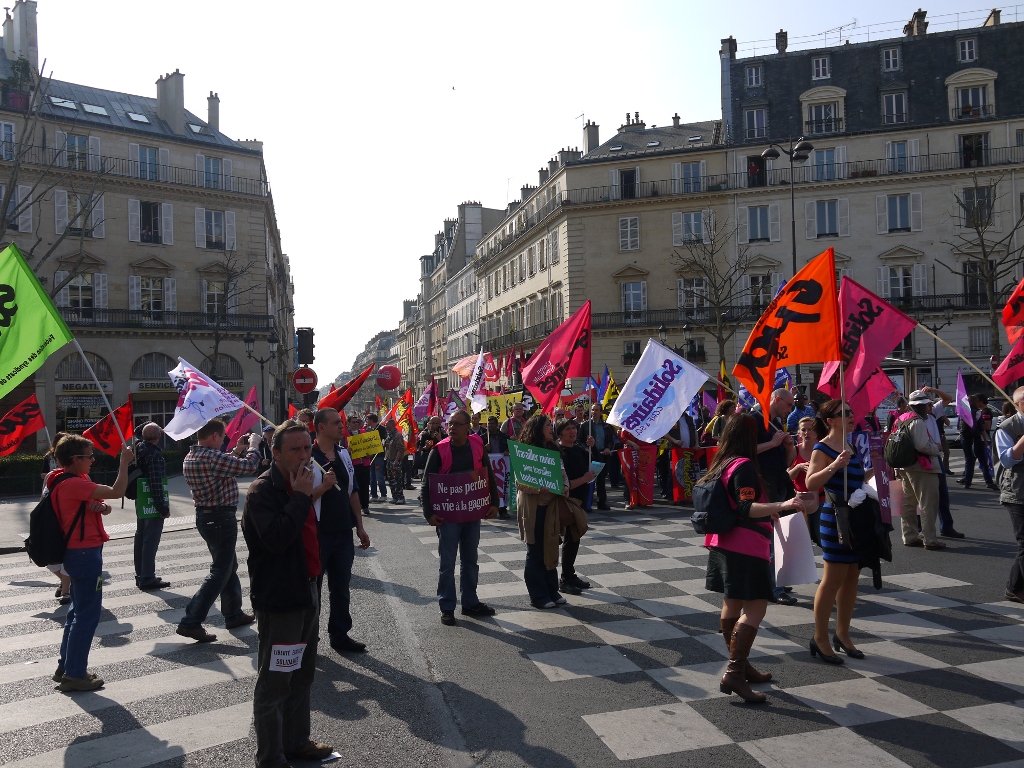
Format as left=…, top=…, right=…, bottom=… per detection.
left=522, top=299, right=591, bottom=413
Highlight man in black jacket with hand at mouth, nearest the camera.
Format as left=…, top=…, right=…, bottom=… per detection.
left=242, top=421, right=334, bottom=768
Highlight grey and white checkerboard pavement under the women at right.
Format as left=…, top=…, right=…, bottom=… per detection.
left=410, top=508, right=1024, bottom=768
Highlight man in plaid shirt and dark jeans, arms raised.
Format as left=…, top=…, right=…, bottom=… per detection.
left=177, top=419, right=262, bottom=643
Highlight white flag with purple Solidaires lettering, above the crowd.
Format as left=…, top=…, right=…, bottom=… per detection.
left=608, top=339, right=709, bottom=442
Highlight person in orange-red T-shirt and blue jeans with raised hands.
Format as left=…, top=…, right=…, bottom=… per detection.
left=44, top=434, right=134, bottom=691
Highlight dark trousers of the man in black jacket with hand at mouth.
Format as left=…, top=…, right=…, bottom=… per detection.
left=253, top=581, right=319, bottom=768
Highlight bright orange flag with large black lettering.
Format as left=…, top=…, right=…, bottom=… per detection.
left=732, top=248, right=843, bottom=418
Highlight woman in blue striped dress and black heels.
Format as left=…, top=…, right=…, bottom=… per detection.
left=805, top=400, right=871, bottom=664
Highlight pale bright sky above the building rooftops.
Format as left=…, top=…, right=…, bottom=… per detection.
left=34, top=0, right=1007, bottom=383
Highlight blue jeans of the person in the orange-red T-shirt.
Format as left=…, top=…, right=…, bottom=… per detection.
left=57, top=546, right=103, bottom=677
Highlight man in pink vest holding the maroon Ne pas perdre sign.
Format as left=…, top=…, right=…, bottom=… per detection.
left=421, top=411, right=498, bottom=627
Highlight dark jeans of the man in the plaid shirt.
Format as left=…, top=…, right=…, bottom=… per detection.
left=181, top=509, right=242, bottom=627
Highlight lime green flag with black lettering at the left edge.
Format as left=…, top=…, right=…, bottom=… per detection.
left=0, top=243, right=74, bottom=397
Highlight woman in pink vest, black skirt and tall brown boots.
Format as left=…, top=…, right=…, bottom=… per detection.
left=697, top=414, right=804, bottom=703
